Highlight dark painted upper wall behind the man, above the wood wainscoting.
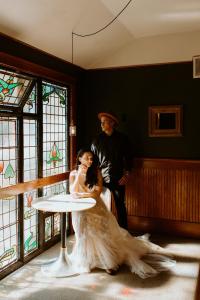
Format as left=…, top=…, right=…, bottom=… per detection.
left=78, top=62, right=200, bottom=159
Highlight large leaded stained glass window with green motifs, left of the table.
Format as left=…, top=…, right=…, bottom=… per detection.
left=0, top=68, right=68, bottom=278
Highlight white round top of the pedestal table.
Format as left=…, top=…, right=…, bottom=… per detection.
left=32, top=194, right=96, bottom=212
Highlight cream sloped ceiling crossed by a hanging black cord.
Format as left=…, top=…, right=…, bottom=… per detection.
left=0, top=0, right=200, bottom=68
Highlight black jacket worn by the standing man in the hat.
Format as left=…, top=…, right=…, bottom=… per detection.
left=91, top=130, right=132, bottom=184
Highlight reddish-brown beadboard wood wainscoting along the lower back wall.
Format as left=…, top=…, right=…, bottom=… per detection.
left=126, top=158, right=200, bottom=238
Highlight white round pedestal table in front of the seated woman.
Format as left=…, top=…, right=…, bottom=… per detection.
left=32, top=194, right=96, bottom=277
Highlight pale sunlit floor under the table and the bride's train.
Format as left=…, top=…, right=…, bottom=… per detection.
left=0, top=236, right=200, bottom=300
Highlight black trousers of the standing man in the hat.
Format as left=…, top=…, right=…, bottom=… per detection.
left=104, top=183, right=128, bottom=229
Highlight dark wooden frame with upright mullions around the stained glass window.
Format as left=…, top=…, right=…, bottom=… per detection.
left=0, top=52, right=76, bottom=278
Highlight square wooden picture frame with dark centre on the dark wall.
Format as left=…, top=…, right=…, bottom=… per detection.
left=148, top=105, right=183, bottom=137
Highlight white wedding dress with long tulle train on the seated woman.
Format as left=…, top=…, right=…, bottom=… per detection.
left=69, top=170, right=175, bottom=278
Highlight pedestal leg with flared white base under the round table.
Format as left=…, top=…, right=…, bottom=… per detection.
left=42, top=212, right=78, bottom=277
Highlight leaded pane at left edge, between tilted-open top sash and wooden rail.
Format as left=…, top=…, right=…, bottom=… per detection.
left=0, top=117, right=17, bottom=188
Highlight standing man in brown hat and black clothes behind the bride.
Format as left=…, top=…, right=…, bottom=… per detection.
left=91, top=112, right=132, bottom=229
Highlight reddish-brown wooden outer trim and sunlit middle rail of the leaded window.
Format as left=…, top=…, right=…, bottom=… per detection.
left=0, top=51, right=77, bottom=278
